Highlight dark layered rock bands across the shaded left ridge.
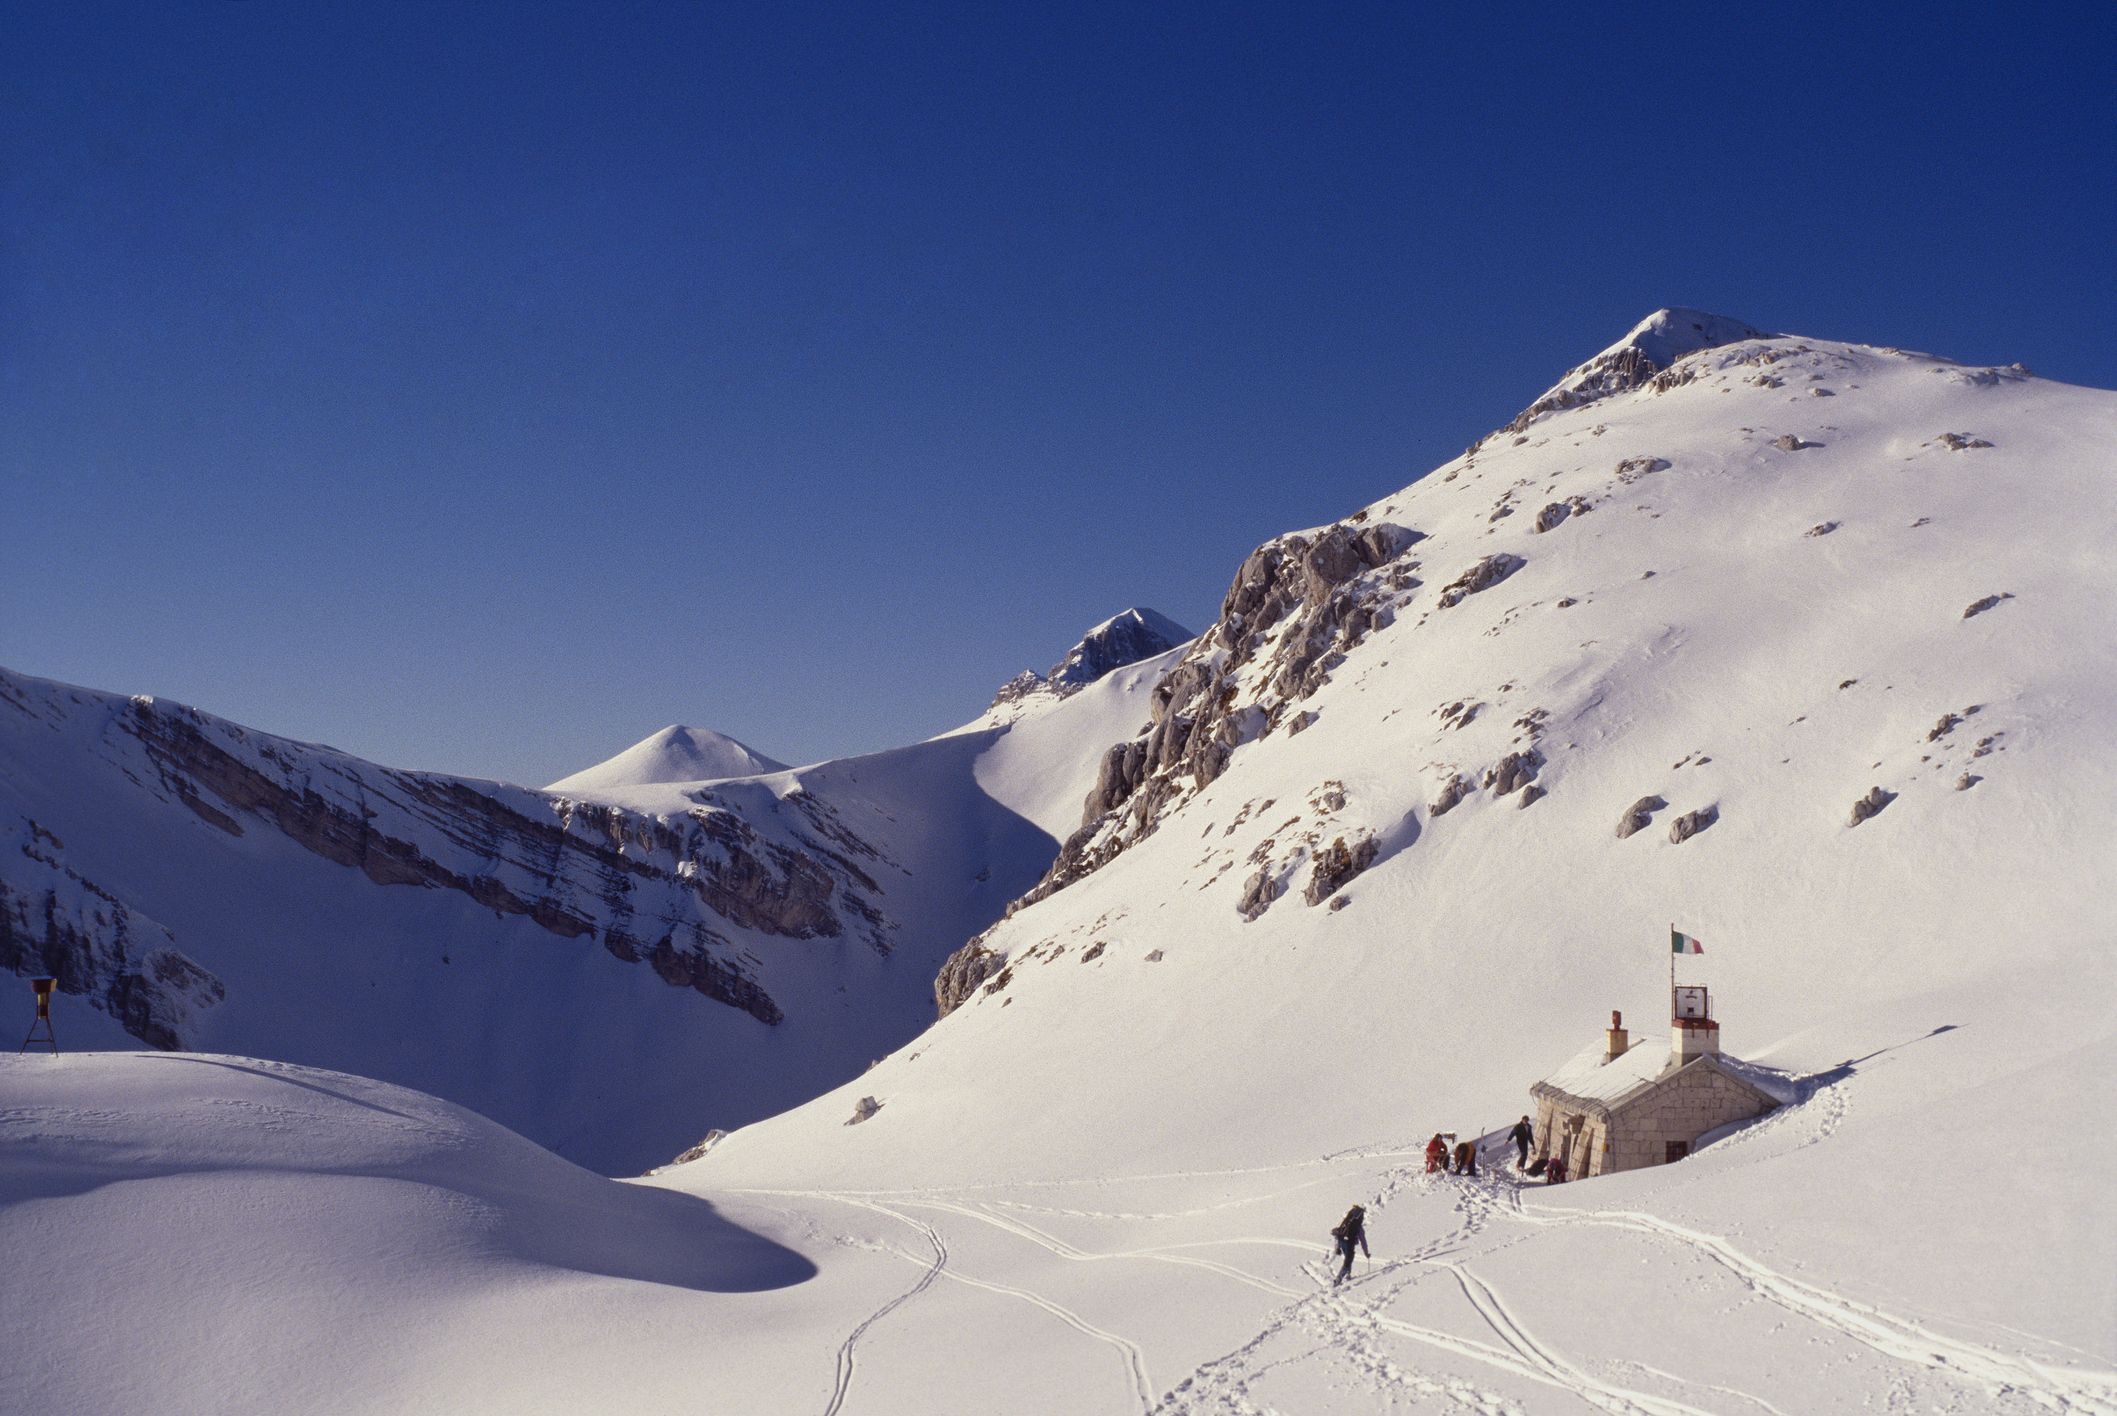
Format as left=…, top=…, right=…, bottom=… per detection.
left=0, top=668, right=927, bottom=1032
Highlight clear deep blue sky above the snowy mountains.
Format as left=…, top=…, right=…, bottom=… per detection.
left=0, top=0, right=2117, bottom=783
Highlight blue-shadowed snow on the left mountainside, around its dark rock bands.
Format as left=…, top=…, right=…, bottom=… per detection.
left=0, top=639, right=1177, bottom=1175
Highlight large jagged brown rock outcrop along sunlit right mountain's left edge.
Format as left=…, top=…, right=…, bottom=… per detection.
left=1010, top=521, right=1421, bottom=914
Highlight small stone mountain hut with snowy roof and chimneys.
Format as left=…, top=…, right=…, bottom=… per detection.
left=1528, top=988, right=1778, bottom=1179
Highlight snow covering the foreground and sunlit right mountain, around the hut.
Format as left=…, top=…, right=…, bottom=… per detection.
left=0, top=315, right=2117, bottom=1416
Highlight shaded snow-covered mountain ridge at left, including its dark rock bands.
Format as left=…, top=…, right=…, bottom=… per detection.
left=0, top=609, right=1193, bottom=1173
